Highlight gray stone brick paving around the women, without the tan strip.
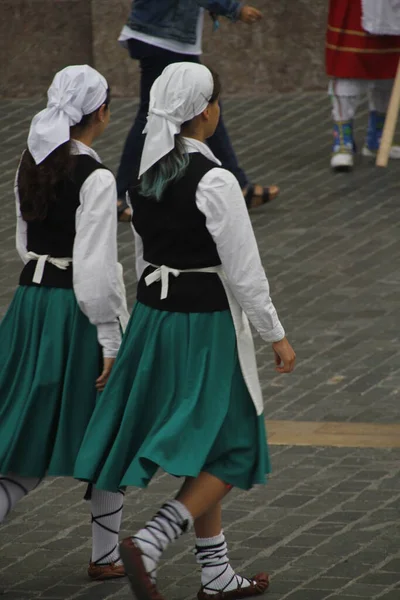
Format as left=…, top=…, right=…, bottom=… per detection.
left=0, top=94, right=400, bottom=600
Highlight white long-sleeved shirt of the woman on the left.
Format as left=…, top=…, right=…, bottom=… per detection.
left=15, top=140, right=125, bottom=358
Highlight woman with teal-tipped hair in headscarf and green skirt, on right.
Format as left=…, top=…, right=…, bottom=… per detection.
left=75, top=63, right=295, bottom=600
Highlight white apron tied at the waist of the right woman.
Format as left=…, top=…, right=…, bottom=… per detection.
left=145, top=265, right=264, bottom=415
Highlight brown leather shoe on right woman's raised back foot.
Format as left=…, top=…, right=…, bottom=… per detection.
left=119, top=538, right=165, bottom=600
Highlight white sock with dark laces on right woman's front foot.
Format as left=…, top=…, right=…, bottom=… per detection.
left=196, top=531, right=251, bottom=595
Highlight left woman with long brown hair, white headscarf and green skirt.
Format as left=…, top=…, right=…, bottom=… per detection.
left=0, top=65, right=127, bottom=579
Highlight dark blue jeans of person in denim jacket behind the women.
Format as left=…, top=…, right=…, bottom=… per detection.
left=117, top=40, right=248, bottom=198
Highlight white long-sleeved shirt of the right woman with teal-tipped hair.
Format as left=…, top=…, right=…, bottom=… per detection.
left=134, top=138, right=285, bottom=342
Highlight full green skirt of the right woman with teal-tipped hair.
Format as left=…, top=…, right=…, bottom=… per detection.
left=75, top=303, right=270, bottom=491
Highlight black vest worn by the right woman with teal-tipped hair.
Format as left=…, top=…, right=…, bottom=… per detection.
left=130, top=152, right=228, bottom=312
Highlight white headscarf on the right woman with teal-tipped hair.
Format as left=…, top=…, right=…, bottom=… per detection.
left=139, top=62, right=214, bottom=177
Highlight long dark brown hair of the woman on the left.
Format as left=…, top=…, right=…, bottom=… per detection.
left=17, top=90, right=111, bottom=221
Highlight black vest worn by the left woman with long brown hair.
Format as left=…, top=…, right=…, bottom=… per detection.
left=19, top=154, right=105, bottom=288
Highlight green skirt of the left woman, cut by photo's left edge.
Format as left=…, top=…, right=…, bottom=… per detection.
left=0, top=286, right=101, bottom=477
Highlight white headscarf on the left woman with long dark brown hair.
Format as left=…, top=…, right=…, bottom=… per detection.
left=28, top=65, right=108, bottom=165
